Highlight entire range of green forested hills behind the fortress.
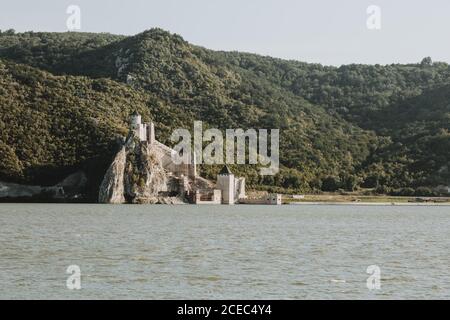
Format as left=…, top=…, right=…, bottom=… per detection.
left=0, top=29, right=450, bottom=198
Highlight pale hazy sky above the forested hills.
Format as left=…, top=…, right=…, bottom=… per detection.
left=0, top=0, right=450, bottom=65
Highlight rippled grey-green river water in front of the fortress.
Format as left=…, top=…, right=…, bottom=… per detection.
left=0, top=204, right=450, bottom=299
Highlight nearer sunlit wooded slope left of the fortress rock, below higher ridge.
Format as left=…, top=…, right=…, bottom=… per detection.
left=0, top=61, right=151, bottom=192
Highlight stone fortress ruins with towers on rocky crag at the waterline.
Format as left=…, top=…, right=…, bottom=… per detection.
left=98, top=112, right=281, bottom=205
